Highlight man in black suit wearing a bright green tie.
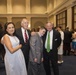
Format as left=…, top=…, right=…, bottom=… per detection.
left=43, top=22, right=61, bottom=75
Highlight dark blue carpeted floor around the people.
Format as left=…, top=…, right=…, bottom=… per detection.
left=0, top=55, right=76, bottom=75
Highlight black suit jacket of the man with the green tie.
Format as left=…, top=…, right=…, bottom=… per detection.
left=43, top=29, right=61, bottom=57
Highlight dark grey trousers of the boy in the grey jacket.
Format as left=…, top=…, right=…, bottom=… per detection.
left=28, top=62, right=46, bottom=75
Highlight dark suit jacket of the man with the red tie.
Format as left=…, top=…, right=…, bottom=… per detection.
left=16, top=28, right=30, bottom=56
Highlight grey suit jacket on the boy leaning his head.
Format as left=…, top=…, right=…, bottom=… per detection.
left=29, top=33, right=43, bottom=63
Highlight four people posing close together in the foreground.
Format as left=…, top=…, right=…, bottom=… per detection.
left=1, top=18, right=61, bottom=75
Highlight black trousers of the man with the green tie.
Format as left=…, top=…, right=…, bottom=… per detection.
left=44, top=51, right=59, bottom=75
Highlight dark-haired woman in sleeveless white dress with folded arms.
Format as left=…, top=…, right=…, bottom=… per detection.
left=1, top=22, right=27, bottom=75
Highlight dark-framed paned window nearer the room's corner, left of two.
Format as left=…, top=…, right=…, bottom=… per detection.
left=56, top=10, right=67, bottom=30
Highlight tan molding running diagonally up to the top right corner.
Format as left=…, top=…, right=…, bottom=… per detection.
left=48, top=0, right=76, bottom=16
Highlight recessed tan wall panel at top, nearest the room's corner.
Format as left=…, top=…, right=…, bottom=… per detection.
left=30, top=0, right=47, bottom=14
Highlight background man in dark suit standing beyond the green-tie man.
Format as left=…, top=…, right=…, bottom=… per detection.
left=63, top=27, right=72, bottom=55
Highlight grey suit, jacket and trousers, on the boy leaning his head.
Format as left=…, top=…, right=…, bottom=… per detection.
left=28, top=33, right=45, bottom=75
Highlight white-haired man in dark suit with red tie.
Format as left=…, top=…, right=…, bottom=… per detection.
left=16, top=18, right=30, bottom=68
